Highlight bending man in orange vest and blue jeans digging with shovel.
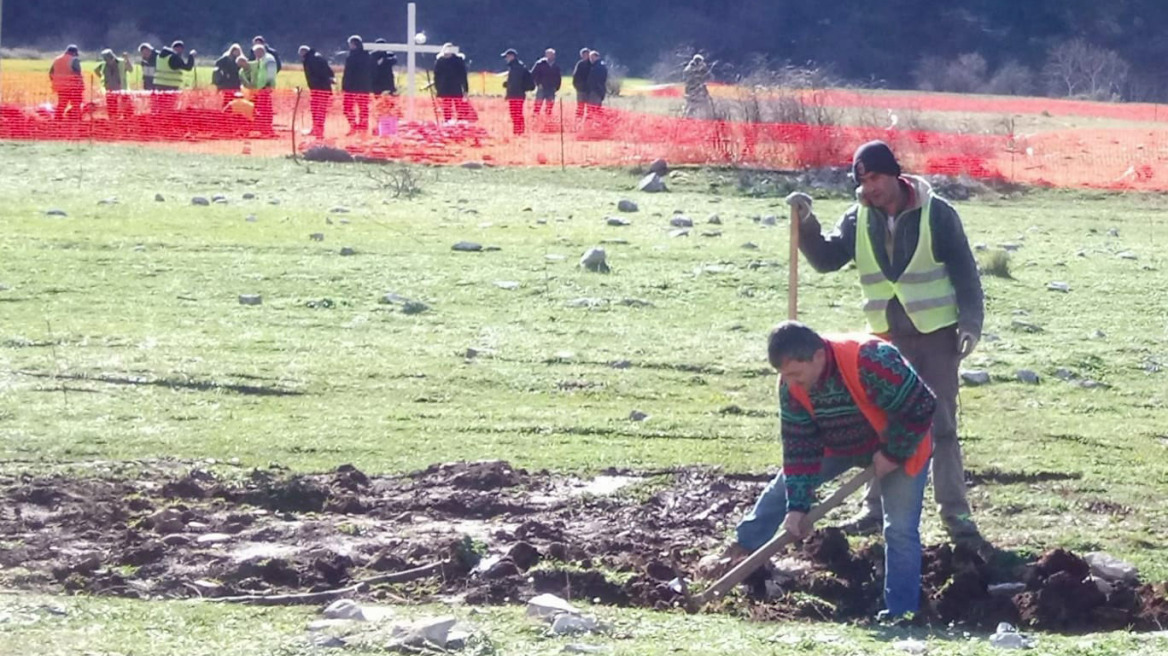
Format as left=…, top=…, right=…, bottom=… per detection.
left=703, top=321, right=937, bottom=621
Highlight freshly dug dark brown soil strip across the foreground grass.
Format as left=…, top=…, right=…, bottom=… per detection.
left=0, top=462, right=1168, bottom=633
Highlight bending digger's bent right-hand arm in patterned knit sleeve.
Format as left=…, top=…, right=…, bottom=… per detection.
left=860, top=341, right=937, bottom=463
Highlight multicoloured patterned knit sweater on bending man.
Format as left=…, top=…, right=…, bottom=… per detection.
left=779, top=341, right=937, bottom=512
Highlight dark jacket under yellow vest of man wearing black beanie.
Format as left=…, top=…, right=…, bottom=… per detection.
left=799, top=176, right=985, bottom=336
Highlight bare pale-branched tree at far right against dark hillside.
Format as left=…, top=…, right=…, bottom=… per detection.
left=1044, top=39, right=1131, bottom=100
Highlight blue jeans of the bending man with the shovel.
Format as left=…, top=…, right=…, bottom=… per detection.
left=737, top=458, right=929, bottom=616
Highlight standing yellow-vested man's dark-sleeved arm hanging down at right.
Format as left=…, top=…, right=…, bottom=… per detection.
left=930, top=200, right=986, bottom=337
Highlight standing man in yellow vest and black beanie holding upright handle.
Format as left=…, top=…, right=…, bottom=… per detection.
left=787, top=141, right=986, bottom=547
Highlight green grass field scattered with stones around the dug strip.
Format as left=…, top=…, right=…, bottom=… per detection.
left=0, top=144, right=1168, bottom=655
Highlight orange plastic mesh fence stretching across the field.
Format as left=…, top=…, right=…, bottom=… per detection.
left=0, top=78, right=1168, bottom=190
